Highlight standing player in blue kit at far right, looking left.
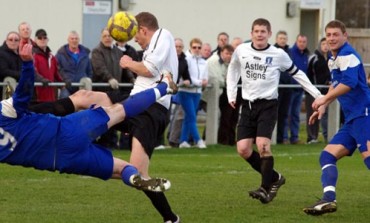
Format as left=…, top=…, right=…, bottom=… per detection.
left=303, top=20, right=370, bottom=215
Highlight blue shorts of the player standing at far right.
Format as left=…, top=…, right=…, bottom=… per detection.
left=329, top=116, right=370, bottom=155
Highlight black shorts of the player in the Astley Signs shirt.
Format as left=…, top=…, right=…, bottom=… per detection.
left=237, top=99, right=278, bottom=141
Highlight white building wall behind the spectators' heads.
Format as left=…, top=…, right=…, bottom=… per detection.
left=0, top=0, right=335, bottom=53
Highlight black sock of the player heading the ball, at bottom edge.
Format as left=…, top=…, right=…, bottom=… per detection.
left=144, top=191, right=177, bottom=222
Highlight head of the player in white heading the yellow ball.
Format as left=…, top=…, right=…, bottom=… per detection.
left=135, top=12, right=159, bottom=49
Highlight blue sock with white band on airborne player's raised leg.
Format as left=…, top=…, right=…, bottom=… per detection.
left=122, top=82, right=167, bottom=118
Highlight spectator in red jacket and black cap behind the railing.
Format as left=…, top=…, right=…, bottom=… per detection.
left=34, top=29, right=62, bottom=102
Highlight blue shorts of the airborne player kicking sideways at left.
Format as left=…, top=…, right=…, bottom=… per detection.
left=55, top=108, right=113, bottom=180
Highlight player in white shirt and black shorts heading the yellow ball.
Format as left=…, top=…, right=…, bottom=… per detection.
left=120, top=12, right=180, bottom=222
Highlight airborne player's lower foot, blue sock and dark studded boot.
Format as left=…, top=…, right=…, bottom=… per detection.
left=121, top=165, right=171, bottom=192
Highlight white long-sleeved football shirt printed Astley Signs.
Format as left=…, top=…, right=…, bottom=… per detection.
left=226, top=42, right=320, bottom=102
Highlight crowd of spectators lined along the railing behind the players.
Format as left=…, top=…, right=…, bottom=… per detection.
left=0, top=22, right=330, bottom=149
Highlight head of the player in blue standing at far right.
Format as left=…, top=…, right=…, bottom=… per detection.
left=325, top=20, right=347, bottom=55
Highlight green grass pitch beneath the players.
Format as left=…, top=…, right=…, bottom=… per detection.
left=0, top=144, right=370, bottom=223
